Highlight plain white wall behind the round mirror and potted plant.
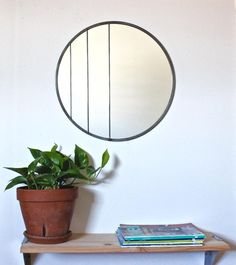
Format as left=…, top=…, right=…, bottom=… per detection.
left=0, top=0, right=236, bottom=265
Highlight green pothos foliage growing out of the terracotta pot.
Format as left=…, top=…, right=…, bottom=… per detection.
left=5, top=144, right=110, bottom=190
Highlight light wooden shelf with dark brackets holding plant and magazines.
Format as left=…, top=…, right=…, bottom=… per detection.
left=20, top=233, right=230, bottom=265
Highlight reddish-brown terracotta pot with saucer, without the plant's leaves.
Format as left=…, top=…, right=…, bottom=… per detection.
left=17, top=187, right=78, bottom=244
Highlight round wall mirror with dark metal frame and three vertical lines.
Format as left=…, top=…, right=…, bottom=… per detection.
left=56, top=21, right=175, bottom=141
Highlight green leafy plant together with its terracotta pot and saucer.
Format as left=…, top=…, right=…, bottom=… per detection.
left=5, top=144, right=109, bottom=244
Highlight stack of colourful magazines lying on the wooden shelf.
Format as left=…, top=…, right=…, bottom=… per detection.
left=116, top=223, right=206, bottom=247
